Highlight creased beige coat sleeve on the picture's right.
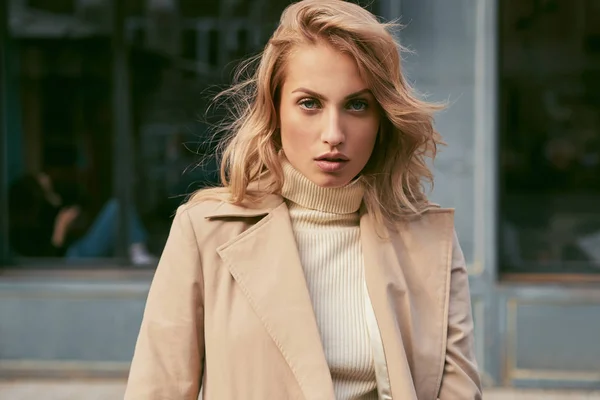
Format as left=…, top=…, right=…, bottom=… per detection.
left=438, top=232, right=482, bottom=400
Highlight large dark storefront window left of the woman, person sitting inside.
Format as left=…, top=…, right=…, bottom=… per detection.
left=2, top=0, right=384, bottom=268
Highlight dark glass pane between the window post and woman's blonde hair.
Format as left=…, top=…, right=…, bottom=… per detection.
left=127, top=0, right=378, bottom=254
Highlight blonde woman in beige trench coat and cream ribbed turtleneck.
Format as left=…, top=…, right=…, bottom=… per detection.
left=125, top=0, right=481, bottom=400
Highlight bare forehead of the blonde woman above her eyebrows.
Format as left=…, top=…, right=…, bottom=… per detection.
left=284, top=44, right=367, bottom=92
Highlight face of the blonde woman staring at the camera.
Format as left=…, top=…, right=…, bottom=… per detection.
left=279, top=44, right=380, bottom=187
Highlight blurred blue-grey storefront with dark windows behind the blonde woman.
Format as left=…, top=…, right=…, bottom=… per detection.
left=0, top=0, right=600, bottom=399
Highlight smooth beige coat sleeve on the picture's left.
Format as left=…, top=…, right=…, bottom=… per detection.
left=125, top=208, right=204, bottom=400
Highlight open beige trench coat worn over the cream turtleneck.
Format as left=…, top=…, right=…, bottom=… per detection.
left=125, top=195, right=481, bottom=400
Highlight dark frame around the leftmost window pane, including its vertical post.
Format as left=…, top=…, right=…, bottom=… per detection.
left=0, top=1, right=138, bottom=268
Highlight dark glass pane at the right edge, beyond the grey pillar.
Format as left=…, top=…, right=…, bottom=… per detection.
left=500, top=0, right=600, bottom=273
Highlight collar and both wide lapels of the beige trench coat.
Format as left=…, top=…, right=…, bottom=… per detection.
left=206, top=191, right=453, bottom=399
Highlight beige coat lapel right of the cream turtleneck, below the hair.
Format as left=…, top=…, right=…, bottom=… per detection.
left=361, top=210, right=454, bottom=400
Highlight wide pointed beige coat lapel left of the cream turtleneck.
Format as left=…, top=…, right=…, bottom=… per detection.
left=213, top=202, right=335, bottom=399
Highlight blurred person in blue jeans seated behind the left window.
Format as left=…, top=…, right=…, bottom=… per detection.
left=9, top=173, right=156, bottom=265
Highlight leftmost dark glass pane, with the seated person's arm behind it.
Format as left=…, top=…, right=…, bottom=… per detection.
left=7, top=5, right=118, bottom=265
